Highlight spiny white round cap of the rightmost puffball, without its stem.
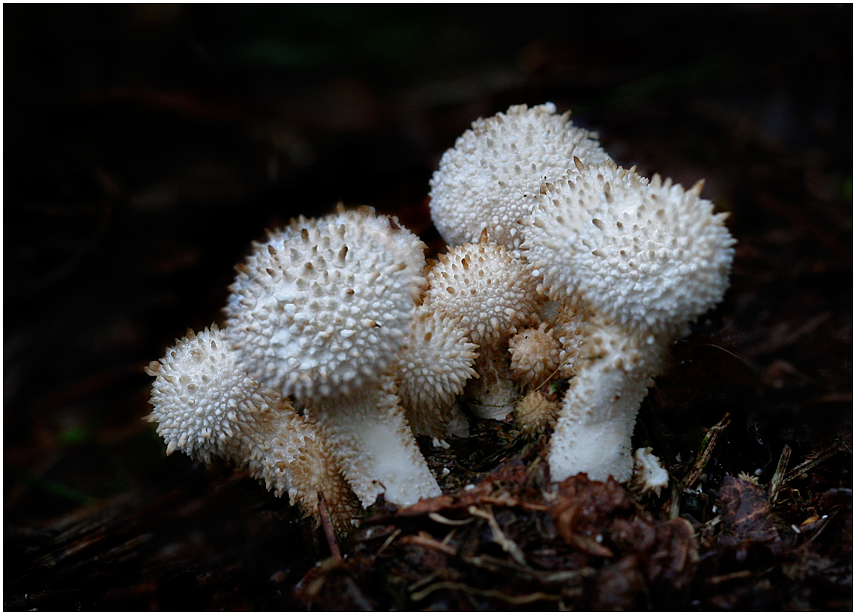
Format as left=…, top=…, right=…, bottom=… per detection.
left=524, top=162, right=734, bottom=334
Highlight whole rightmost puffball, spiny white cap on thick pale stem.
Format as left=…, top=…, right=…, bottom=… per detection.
left=523, top=160, right=734, bottom=481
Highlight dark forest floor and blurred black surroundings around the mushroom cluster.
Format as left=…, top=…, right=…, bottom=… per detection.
left=4, top=5, right=853, bottom=611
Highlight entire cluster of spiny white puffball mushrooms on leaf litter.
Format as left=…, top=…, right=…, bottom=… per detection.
left=147, top=103, right=734, bottom=533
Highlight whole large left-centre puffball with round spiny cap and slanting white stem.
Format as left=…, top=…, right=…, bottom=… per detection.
left=226, top=207, right=440, bottom=505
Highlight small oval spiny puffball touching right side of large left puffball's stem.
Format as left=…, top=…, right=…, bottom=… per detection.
left=395, top=306, right=478, bottom=438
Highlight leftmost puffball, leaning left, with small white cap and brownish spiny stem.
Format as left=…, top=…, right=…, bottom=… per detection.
left=146, top=325, right=359, bottom=534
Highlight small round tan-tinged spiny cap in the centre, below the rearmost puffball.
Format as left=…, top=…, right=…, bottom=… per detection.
left=423, top=241, right=538, bottom=345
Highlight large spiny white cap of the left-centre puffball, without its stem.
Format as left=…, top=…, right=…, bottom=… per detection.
left=225, top=208, right=425, bottom=398
